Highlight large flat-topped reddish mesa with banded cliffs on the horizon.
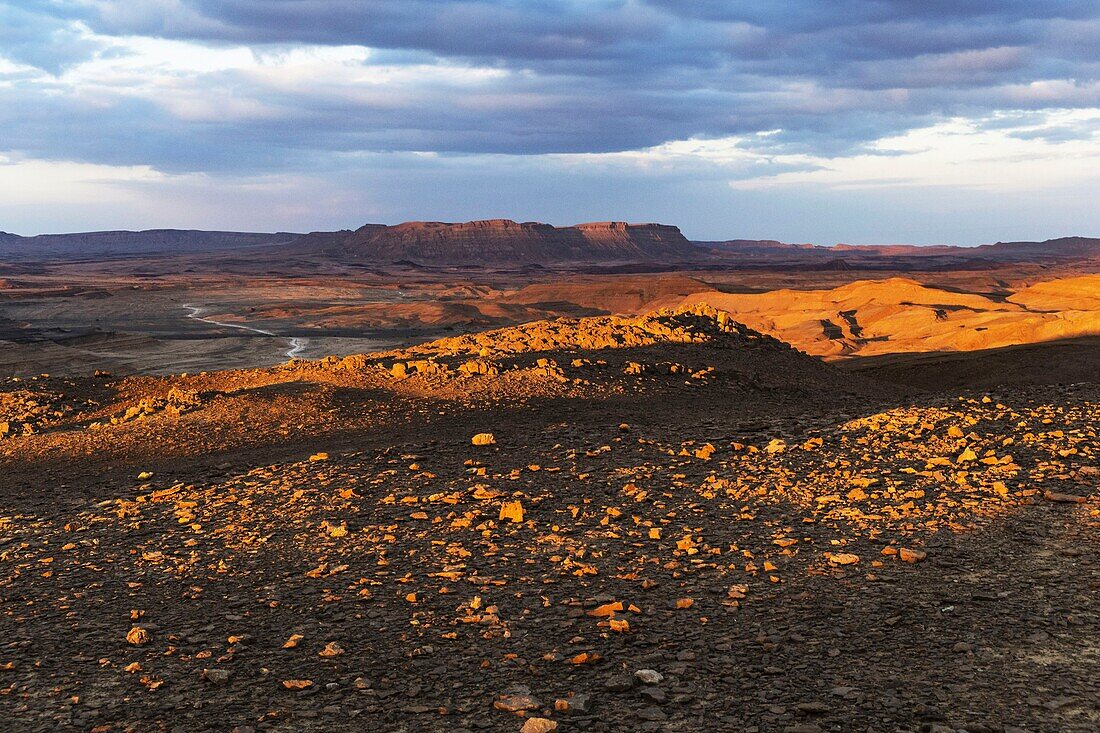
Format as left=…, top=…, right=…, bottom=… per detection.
left=327, top=219, right=701, bottom=264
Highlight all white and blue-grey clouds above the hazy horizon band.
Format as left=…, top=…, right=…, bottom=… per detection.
left=0, top=0, right=1100, bottom=236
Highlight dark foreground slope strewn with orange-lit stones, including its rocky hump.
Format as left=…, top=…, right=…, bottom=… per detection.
left=0, top=308, right=1100, bottom=733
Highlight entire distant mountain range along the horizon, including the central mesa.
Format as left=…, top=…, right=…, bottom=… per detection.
left=0, top=219, right=1100, bottom=270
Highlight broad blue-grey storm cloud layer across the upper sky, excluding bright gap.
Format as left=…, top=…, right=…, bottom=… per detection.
left=0, top=0, right=1100, bottom=172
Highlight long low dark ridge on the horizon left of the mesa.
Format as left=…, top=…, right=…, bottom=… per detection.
left=0, top=229, right=301, bottom=260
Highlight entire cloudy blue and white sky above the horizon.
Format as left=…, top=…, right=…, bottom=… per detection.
left=0, top=0, right=1100, bottom=244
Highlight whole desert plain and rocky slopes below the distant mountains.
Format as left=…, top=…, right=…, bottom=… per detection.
left=0, top=224, right=1100, bottom=732
